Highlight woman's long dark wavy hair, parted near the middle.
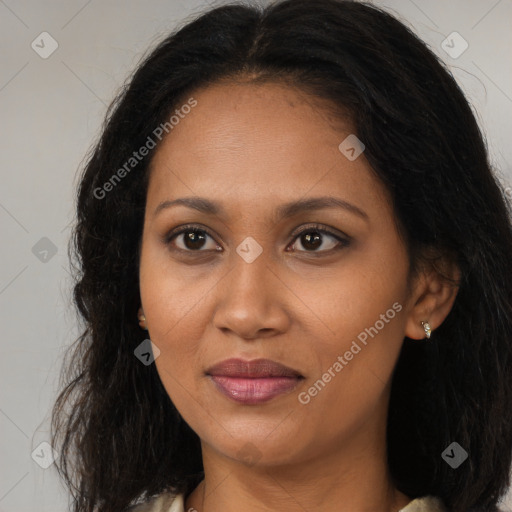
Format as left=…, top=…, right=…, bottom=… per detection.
left=52, top=0, right=512, bottom=512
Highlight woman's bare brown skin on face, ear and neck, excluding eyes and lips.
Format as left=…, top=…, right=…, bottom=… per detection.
left=140, top=82, right=457, bottom=512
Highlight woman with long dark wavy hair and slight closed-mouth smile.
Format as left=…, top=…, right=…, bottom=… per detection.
left=52, top=0, right=512, bottom=512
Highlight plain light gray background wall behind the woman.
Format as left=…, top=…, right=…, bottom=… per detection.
left=0, top=0, right=512, bottom=512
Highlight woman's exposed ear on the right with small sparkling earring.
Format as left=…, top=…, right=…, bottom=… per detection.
left=405, top=258, right=461, bottom=340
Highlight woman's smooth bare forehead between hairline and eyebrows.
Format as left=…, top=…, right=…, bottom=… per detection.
left=147, top=83, right=386, bottom=220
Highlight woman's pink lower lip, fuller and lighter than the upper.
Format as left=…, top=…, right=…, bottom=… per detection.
left=210, top=375, right=301, bottom=405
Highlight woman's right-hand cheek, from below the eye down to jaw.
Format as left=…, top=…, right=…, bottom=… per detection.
left=301, top=245, right=408, bottom=424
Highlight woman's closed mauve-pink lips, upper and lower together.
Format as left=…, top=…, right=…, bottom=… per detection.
left=206, top=359, right=304, bottom=405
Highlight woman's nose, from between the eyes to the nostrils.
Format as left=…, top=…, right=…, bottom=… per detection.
left=213, top=248, right=291, bottom=339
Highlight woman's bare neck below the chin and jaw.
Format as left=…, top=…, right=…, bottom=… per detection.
left=185, top=412, right=410, bottom=512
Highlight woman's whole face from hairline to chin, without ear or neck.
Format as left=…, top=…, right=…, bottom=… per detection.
left=140, top=84, right=411, bottom=464
